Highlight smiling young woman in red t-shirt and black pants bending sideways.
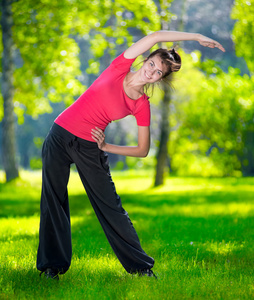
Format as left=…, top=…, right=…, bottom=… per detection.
left=37, top=31, right=225, bottom=279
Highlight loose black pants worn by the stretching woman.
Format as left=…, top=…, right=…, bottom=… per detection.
left=37, top=124, right=154, bottom=274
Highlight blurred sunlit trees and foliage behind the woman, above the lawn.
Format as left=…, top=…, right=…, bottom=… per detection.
left=0, top=0, right=254, bottom=186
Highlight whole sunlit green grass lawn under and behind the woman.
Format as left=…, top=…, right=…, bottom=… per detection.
left=0, top=172, right=254, bottom=299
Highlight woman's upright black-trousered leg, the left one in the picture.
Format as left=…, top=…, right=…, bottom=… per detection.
left=37, top=129, right=72, bottom=273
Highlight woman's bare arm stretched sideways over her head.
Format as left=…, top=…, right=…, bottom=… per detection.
left=124, top=30, right=225, bottom=59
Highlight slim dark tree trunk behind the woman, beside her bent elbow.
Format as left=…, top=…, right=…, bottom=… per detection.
left=154, top=83, right=171, bottom=186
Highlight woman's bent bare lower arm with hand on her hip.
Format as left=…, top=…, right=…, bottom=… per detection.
left=92, top=126, right=150, bottom=157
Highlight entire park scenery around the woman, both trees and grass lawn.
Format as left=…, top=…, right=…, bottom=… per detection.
left=0, top=0, right=254, bottom=299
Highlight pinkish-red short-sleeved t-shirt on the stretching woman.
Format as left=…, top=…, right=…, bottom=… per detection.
left=55, top=53, right=150, bottom=142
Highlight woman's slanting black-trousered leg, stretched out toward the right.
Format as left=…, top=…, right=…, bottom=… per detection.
left=74, top=143, right=154, bottom=273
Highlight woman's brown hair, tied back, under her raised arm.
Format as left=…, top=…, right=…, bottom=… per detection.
left=146, top=48, right=182, bottom=78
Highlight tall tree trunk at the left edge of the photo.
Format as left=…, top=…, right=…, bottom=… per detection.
left=1, top=0, right=19, bottom=181
